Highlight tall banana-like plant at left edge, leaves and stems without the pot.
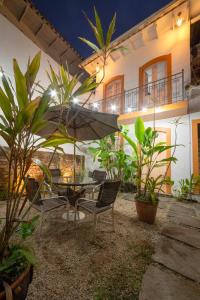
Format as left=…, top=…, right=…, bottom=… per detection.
left=0, top=53, right=74, bottom=261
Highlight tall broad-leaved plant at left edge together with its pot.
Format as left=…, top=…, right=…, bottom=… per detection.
left=0, top=53, right=76, bottom=300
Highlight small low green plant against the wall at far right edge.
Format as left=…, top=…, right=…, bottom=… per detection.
left=174, top=174, right=200, bottom=200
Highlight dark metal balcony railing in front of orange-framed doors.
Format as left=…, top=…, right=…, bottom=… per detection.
left=89, top=71, right=184, bottom=114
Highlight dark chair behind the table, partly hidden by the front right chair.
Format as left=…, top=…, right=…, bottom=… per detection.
left=85, top=170, right=107, bottom=199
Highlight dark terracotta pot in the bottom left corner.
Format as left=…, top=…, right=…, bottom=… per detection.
left=0, top=266, right=33, bottom=300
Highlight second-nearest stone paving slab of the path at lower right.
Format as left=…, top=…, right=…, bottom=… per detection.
left=153, top=237, right=200, bottom=282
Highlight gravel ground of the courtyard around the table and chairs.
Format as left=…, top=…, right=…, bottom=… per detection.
left=1, top=194, right=173, bottom=300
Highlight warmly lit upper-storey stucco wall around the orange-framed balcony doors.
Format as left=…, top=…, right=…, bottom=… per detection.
left=93, top=22, right=190, bottom=100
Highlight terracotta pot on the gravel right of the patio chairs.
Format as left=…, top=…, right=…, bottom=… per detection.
left=135, top=200, right=158, bottom=224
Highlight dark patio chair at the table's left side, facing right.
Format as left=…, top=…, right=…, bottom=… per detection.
left=25, top=177, right=68, bottom=235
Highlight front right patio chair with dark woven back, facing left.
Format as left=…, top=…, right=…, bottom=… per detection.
left=76, top=181, right=121, bottom=234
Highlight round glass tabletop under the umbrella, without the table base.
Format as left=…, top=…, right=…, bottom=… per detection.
left=52, top=176, right=97, bottom=186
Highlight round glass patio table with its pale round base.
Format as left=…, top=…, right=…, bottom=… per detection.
left=52, top=176, right=97, bottom=221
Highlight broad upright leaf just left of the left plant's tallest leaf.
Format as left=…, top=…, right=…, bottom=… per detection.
left=13, top=59, right=28, bottom=109
